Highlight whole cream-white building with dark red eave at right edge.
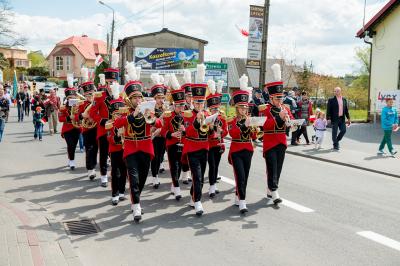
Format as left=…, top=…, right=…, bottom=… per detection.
left=357, top=0, right=400, bottom=113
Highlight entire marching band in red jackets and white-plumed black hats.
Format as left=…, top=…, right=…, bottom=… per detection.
left=59, top=62, right=293, bottom=222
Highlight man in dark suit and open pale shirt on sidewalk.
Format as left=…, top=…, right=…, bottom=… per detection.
left=326, top=87, right=351, bottom=150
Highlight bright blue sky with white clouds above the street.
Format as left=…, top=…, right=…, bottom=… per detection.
left=10, top=0, right=388, bottom=76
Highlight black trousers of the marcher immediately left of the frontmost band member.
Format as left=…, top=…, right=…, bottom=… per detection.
left=110, top=150, right=127, bottom=197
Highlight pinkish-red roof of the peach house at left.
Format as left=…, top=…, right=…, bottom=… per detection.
left=50, top=35, right=107, bottom=60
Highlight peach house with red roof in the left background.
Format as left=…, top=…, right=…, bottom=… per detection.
left=47, top=35, right=107, bottom=79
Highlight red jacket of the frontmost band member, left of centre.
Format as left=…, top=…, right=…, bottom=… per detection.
left=114, top=110, right=154, bottom=160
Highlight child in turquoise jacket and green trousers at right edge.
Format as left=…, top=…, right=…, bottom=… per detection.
left=378, top=97, right=399, bottom=155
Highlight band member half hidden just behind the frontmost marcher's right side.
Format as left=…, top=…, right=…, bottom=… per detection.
left=151, top=73, right=166, bottom=189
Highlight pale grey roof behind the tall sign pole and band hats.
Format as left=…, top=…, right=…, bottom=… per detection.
left=221, top=57, right=298, bottom=88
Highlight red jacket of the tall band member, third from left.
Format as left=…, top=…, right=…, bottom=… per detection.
left=89, top=91, right=112, bottom=139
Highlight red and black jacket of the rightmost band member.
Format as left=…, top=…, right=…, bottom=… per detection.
left=259, top=103, right=293, bottom=154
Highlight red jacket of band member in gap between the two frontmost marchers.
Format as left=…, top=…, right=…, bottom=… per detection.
left=161, top=111, right=185, bottom=148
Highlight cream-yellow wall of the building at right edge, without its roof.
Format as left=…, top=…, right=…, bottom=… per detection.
left=371, top=6, right=400, bottom=112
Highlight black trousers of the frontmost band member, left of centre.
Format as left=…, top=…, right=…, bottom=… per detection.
left=125, top=151, right=150, bottom=204
